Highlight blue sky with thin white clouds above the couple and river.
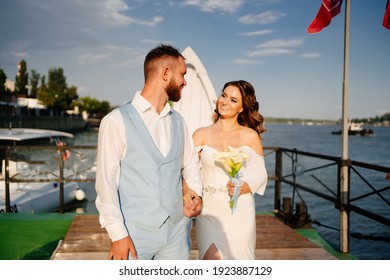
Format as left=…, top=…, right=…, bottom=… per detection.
left=0, top=0, right=390, bottom=120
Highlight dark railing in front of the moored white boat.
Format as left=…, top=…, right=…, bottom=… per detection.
left=0, top=146, right=97, bottom=213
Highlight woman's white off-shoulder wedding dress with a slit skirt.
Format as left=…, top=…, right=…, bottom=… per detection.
left=196, top=145, right=267, bottom=260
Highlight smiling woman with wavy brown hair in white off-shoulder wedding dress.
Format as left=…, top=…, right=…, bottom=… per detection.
left=187, top=80, right=267, bottom=260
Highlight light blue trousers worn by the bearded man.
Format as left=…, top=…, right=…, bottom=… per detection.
left=128, top=217, right=192, bottom=260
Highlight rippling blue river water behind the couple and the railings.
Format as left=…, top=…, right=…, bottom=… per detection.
left=69, top=124, right=390, bottom=259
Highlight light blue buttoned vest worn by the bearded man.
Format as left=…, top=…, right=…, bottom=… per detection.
left=119, top=103, right=184, bottom=228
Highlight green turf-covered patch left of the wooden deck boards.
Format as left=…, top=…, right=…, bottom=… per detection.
left=0, top=213, right=75, bottom=260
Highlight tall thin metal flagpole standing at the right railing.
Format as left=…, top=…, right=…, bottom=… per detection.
left=340, top=0, right=350, bottom=253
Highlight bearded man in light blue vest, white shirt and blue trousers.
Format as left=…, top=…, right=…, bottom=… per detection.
left=96, top=45, right=202, bottom=260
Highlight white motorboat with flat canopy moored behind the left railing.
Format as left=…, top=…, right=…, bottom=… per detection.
left=0, top=128, right=88, bottom=213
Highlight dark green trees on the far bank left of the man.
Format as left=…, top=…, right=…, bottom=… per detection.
left=0, top=60, right=112, bottom=118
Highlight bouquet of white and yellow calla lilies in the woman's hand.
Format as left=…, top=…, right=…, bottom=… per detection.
left=214, top=146, right=250, bottom=214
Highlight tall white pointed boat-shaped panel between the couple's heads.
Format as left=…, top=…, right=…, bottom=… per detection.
left=172, top=47, right=217, bottom=135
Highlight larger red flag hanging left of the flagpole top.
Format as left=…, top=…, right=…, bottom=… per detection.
left=307, top=0, right=343, bottom=33
